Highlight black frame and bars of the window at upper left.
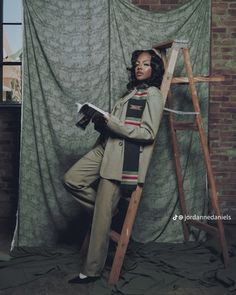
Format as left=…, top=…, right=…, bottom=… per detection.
left=0, top=0, right=22, bottom=106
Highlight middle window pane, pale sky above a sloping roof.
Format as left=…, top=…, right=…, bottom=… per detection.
left=3, top=25, right=22, bottom=61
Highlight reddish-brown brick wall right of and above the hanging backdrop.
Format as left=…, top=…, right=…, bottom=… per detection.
left=132, top=0, right=236, bottom=221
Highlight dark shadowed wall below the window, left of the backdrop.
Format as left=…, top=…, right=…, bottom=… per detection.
left=0, top=106, right=20, bottom=233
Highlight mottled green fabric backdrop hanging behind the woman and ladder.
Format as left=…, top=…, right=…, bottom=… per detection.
left=13, top=0, right=211, bottom=246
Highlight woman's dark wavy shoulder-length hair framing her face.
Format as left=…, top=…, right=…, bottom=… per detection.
left=127, top=49, right=164, bottom=90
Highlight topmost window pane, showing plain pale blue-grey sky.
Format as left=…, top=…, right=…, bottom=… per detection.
left=3, top=0, right=22, bottom=23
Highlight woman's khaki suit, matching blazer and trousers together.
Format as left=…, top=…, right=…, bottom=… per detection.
left=64, top=87, right=164, bottom=276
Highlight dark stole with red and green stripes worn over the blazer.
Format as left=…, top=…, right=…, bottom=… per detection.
left=121, top=90, right=148, bottom=190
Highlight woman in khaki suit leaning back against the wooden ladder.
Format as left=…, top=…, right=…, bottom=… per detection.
left=64, top=49, right=164, bottom=284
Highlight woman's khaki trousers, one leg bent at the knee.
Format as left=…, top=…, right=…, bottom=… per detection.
left=64, top=145, right=121, bottom=276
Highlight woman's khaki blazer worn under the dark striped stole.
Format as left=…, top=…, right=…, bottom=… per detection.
left=100, top=87, right=164, bottom=183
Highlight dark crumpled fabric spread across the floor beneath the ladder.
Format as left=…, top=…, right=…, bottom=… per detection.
left=0, top=242, right=236, bottom=295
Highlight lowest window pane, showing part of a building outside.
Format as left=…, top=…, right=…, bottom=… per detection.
left=2, top=66, right=21, bottom=102
